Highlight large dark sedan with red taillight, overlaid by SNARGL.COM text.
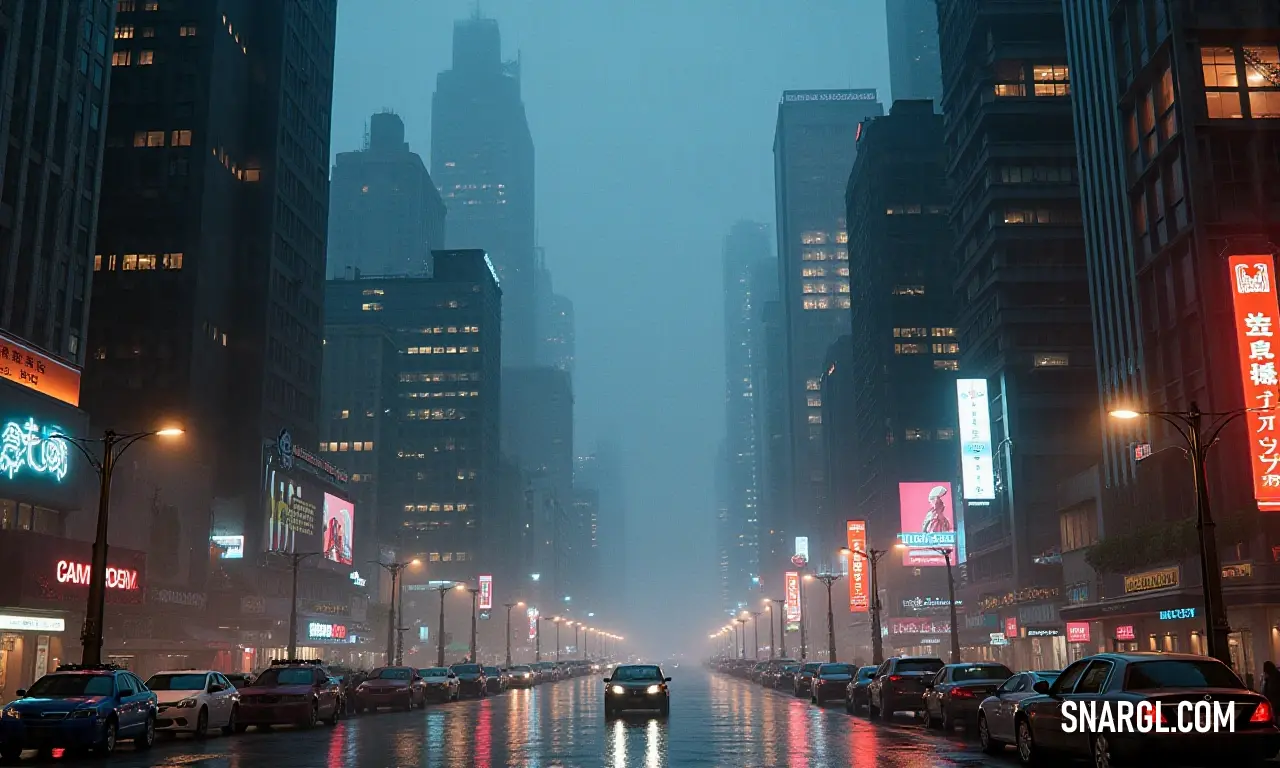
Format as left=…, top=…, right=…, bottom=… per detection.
left=1014, top=652, right=1280, bottom=768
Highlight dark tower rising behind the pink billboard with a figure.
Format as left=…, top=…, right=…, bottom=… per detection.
left=844, top=100, right=960, bottom=655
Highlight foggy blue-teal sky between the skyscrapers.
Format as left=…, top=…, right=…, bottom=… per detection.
left=333, top=0, right=890, bottom=653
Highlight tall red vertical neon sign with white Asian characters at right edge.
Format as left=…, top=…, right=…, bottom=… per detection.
left=1230, top=255, right=1280, bottom=512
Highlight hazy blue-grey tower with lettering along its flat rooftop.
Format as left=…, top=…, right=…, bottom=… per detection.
left=762, top=90, right=883, bottom=570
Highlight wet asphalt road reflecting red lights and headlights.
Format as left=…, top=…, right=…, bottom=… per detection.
left=23, top=666, right=1016, bottom=768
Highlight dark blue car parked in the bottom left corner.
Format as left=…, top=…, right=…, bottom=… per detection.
left=0, top=664, right=157, bottom=760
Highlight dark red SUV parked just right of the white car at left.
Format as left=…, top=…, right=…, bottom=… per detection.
left=236, top=659, right=343, bottom=732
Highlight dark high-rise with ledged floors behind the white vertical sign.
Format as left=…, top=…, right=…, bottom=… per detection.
left=931, top=0, right=1101, bottom=653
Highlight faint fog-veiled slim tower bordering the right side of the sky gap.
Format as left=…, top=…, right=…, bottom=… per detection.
left=722, top=221, right=777, bottom=603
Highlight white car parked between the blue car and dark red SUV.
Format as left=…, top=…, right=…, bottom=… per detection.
left=147, top=669, right=239, bottom=739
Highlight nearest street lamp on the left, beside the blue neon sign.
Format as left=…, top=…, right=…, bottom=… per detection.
left=51, top=426, right=183, bottom=664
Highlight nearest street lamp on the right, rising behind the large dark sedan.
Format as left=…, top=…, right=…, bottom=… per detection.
left=1111, top=401, right=1254, bottom=666
